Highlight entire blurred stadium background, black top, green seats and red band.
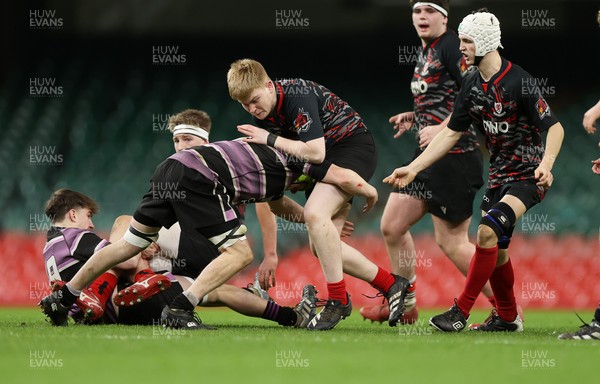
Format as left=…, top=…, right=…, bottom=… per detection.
left=0, top=0, right=600, bottom=308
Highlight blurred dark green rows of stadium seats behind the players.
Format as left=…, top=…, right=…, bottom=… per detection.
left=0, top=50, right=598, bottom=235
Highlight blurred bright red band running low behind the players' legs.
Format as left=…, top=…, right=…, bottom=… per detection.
left=0, top=232, right=600, bottom=309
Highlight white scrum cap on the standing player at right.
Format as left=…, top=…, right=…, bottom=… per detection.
left=458, top=12, right=504, bottom=56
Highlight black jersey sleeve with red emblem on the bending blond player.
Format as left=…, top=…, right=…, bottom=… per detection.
left=285, top=85, right=324, bottom=143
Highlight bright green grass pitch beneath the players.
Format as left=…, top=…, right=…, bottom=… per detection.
left=0, top=308, right=600, bottom=384
